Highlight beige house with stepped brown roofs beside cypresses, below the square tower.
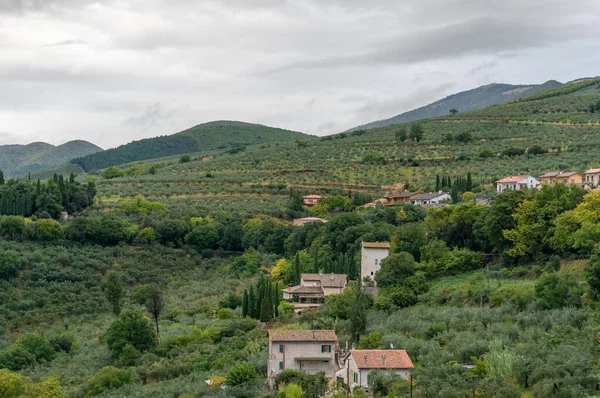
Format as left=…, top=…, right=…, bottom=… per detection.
left=282, top=274, right=348, bottom=310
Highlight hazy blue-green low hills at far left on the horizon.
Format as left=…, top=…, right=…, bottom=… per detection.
left=0, top=140, right=102, bottom=177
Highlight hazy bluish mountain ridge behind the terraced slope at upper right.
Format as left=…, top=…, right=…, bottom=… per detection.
left=348, top=80, right=563, bottom=131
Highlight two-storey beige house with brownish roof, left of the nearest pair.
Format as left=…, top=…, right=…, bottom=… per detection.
left=267, top=330, right=343, bottom=388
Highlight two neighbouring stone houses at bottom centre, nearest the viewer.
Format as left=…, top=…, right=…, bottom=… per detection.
left=267, top=330, right=414, bottom=389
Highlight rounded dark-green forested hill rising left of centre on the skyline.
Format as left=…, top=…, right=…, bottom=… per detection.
left=72, top=121, right=308, bottom=170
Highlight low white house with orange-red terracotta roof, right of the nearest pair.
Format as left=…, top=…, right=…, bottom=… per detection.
left=337, top=350, right=414, bottom=389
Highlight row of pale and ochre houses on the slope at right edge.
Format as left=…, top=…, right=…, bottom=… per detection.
left=496, top=169, right=600, bottom=193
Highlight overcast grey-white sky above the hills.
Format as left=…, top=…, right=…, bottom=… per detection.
left=0, top=0, right=600, bottom=148
